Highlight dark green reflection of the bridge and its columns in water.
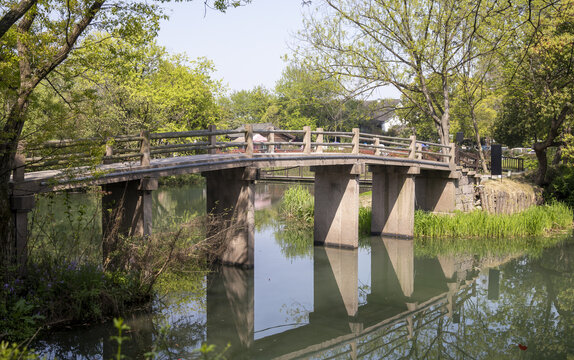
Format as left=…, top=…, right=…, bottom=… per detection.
left=207, top=237, right=477, bottom=359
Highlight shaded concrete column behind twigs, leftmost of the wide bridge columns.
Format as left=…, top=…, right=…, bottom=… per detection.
left=102, top=178, right=157, bottom=242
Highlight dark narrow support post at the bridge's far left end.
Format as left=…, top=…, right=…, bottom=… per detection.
left=10, top=141, right=36, bottom=266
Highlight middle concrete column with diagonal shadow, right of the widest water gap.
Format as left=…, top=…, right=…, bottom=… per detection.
left=313, top=165, right=363, bottom=249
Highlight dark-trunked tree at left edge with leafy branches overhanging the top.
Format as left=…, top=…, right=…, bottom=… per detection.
left=0, top=0, right=249, bottom=260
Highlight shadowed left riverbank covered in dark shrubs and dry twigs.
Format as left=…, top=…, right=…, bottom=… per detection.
left=0, top=212, right=222, bottom=342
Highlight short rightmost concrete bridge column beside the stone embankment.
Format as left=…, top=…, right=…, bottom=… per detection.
left=415, top=172, right=456, bottom=212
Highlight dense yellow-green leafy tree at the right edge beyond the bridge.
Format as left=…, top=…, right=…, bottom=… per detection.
left=496, top=0, right=574, bottom=185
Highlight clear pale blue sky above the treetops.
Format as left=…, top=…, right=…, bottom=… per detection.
left=158, top=0, right=399, bottom=98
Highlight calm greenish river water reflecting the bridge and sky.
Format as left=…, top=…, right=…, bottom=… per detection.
left=30, top=184, right=574, bottom=359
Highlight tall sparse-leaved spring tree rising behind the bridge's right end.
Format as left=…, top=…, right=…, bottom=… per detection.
left=299, top=0, right=511, bottom=145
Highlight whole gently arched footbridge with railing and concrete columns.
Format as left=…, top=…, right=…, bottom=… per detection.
left=7, top=125, right=455, bottom=266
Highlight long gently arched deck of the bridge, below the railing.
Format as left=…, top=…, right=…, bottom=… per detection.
left=12, top=152, right=450, bottom=193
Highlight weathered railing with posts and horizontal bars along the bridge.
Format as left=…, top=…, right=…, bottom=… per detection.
left=16, top=124, right=455, bottom=171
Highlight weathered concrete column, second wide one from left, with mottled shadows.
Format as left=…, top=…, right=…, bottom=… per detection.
left=203, top=167, right=257, bottom=267
